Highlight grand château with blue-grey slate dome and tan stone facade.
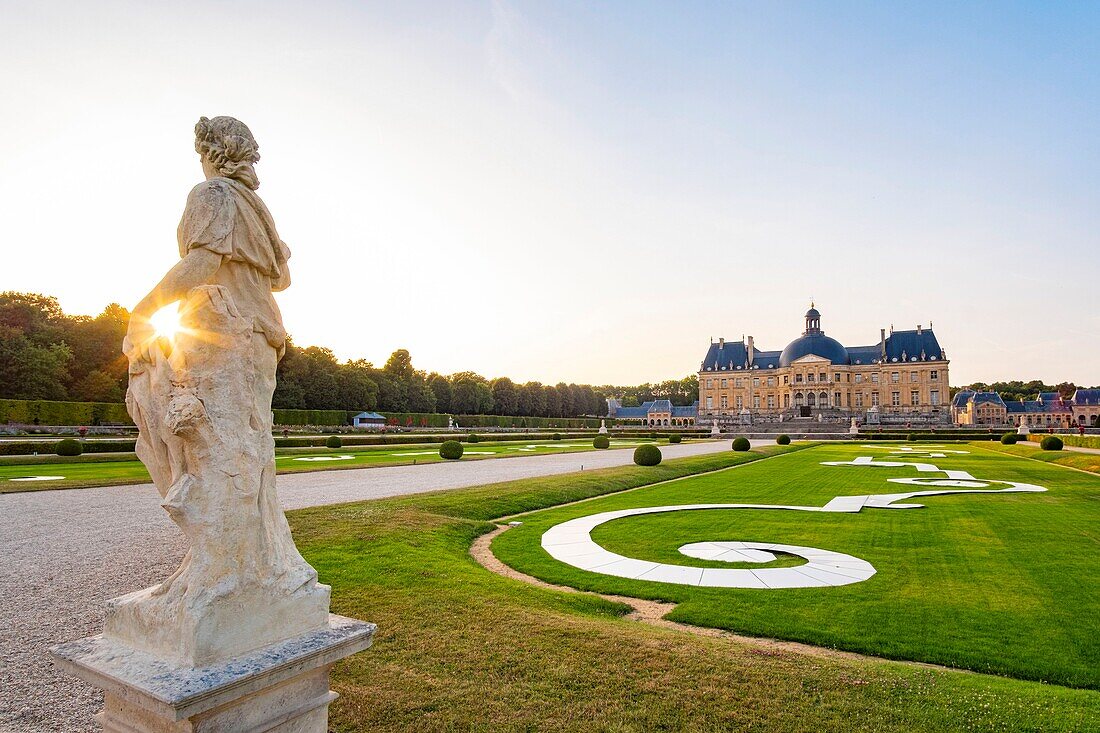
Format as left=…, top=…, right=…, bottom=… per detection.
left=699, top=304, right=952, bottom=425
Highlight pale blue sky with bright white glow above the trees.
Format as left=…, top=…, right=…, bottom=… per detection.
left=0, top=0, right=1100, bottom=384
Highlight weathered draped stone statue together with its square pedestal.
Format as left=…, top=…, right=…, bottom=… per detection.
left=55, top=117, right=374, bottom=731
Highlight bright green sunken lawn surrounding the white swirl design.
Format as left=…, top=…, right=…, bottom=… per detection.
left=493, top=444, right=1100, bottom=689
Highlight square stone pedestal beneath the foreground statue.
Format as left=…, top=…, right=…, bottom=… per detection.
left=51, top=614, right=375, bottom=733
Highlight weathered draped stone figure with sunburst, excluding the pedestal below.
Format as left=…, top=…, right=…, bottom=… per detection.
left=118, top=117, right=329, bottom=666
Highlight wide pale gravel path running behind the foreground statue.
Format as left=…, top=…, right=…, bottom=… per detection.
left=0, top=440, right=739, bottom=733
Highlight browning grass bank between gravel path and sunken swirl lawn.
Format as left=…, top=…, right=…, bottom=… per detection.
left=289, top=449, right=1100, bottom=733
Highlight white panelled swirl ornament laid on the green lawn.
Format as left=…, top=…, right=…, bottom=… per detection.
left=541, top=446, right=1046, bottom=590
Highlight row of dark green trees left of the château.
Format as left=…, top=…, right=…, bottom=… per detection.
left=0, top=292, right=699, bottom=417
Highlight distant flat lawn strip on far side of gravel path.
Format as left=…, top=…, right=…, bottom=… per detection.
left=0, top=438, right=668, bottom=493
